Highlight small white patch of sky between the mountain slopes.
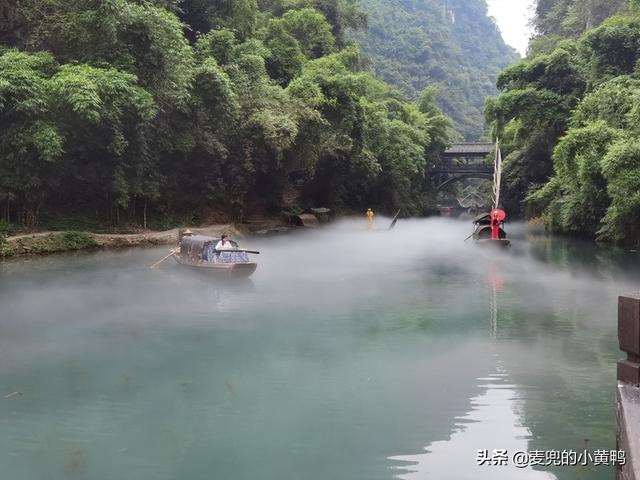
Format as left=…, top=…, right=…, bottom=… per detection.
left=487, top=0, right=534, bottom=57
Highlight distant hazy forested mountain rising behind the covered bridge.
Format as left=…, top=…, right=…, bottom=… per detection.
left=355, top=0, right=519, bottom=140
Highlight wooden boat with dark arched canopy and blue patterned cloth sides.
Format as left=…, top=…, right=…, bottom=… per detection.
left=173, top=235, right=258, bottom=277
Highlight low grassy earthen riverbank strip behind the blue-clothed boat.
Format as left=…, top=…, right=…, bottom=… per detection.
left=0, top=224, right=245, bottom=258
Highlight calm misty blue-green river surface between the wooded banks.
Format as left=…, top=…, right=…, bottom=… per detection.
left=0, top=220, right=638, bottom=480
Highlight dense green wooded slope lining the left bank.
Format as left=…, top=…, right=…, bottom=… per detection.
left=0, top=0, right=449, bottom=232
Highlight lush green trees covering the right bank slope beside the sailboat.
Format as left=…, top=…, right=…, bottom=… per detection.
left=486, top=0, right=640, bottom=245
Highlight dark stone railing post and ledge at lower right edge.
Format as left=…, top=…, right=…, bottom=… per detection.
left=616, top=296, right=640, bottom=480
